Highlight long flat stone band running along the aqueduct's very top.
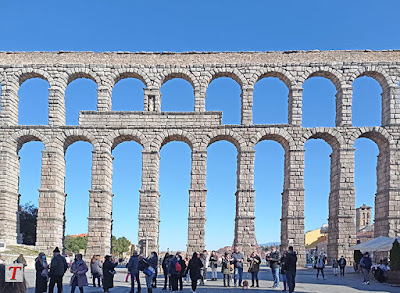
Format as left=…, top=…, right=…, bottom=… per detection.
left=0, top=50, right=400, bottom=66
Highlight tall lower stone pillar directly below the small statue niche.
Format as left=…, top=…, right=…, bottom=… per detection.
left=138, top=150, right=160, bottom=254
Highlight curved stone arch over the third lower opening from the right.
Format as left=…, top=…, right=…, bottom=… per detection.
left=249, top=128, right=295, bottom=152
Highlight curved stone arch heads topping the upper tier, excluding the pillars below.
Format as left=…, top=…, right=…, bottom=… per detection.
left=0, top=65, right=400, bottom=91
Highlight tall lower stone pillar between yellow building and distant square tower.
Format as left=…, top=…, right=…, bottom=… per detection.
left=328, top=148, right=356, bottom=260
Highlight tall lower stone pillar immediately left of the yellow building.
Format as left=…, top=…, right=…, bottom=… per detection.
left=281, top=150, right=306, bottom=266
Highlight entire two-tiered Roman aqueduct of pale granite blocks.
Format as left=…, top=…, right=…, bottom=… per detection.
left=0, top=51, right=400, bottom=263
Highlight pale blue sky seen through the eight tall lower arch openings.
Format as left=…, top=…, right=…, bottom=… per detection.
left=19, top=138, right=379, bottom=251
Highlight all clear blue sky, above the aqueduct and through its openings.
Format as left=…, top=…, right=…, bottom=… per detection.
left=0, top=0, right=400, bottom=250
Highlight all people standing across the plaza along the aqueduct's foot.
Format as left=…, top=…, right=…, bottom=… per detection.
left=0, top=246, right=388, bottom=293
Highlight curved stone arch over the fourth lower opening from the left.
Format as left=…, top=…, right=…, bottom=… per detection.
left=150, top=129, right=198, bottom=151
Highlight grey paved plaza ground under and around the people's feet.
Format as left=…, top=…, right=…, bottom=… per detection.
left=22, top=267, right=400, bottom=293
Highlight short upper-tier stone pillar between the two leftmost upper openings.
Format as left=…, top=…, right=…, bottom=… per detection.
left=49, top=79, right=67, bottom=126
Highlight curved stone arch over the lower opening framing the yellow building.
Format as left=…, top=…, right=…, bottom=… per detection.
left=300, top=127, right=345, bottom=150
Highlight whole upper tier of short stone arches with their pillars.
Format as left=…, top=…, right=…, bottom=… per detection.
left=0, top=66, right=400, bottom=126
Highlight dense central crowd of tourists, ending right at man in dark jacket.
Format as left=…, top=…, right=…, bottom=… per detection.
left=133, top=247, right=297, bottom=293
